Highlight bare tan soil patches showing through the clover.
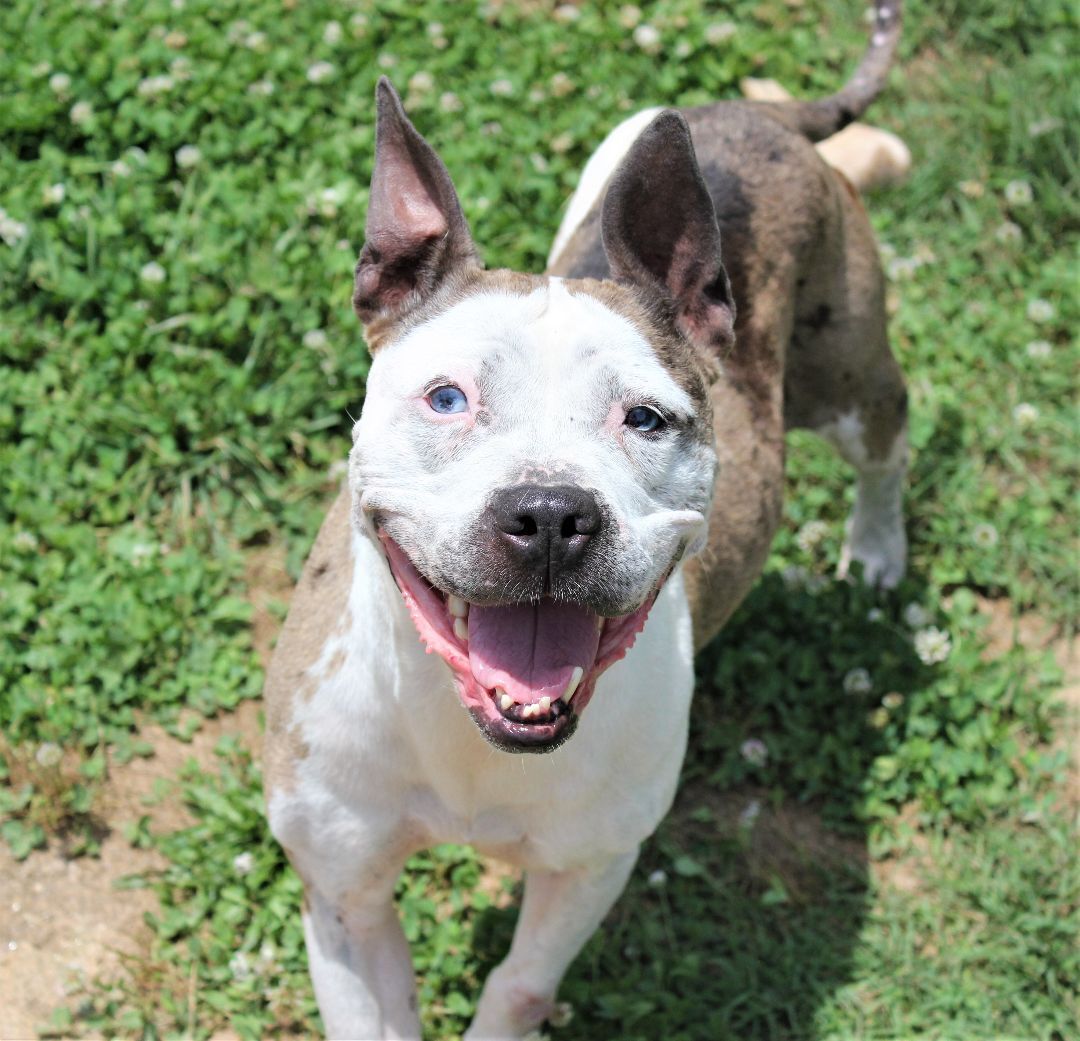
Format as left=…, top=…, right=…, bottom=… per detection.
left=0, top=547, right=1080, bottom=1041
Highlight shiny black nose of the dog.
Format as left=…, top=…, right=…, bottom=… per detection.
left=491, top=485, right=604, bottom=581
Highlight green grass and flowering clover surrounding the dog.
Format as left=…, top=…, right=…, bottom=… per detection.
left=0, top=0, right=1080, bottom=1041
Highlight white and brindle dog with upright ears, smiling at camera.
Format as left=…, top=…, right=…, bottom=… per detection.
left=266, top=0, right=906, bottom=1041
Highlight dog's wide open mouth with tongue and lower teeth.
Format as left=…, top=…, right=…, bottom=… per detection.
left=380, top=532, right=656, bottom=752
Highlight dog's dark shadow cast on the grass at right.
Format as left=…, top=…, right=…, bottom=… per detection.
left=473, top=573, right=928, bottom=1041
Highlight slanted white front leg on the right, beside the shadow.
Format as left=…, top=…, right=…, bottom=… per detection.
left=465, top=849, right=637, bottom=1041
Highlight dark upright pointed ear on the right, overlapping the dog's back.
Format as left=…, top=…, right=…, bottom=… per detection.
left=600, top=109, right=735, bottom=350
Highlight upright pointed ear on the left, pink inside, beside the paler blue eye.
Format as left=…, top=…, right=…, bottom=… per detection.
left=352, top=77, right=480, bottom=324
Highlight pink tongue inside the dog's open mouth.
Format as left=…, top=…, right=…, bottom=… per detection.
left=469, top=599, right=599, bottom=705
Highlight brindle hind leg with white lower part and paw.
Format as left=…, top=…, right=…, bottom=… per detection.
left=784, top=182, right=908, bottom=587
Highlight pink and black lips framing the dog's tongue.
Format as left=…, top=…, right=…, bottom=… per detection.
left=379, top=530, right=659, bottom=752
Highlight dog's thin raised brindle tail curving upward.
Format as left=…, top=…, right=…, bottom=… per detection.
left=766, top=0, right=902, bottom=141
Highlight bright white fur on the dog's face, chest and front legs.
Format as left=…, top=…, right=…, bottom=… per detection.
left=269, top=281, right=715, bottom=1041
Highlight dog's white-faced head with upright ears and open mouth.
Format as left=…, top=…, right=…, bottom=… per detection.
left=350, top=80, right=733, bottom=752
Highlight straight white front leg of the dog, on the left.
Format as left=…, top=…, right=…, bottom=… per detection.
left=303, top=872, right=420, bottom=1041
